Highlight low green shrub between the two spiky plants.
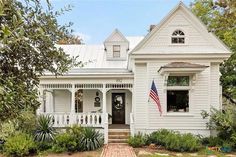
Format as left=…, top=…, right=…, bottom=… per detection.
left=52, top=133, right=79, bottom=153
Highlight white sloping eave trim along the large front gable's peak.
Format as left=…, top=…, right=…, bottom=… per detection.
left=131, top=1, right=231, bottom=54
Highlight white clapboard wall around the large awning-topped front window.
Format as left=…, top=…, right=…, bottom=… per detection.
left=134, top=60, right=212, bottom=134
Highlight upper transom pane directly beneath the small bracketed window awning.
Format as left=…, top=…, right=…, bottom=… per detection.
left=167, top=76, right=189, bottom=86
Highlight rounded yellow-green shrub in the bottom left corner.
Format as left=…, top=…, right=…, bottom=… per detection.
left=3, top=133, right=36, bottom=156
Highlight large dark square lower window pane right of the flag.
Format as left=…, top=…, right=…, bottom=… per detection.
left=167, top=90, right=189, bottom=112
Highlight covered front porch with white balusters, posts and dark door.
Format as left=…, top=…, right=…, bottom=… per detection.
left=38, top=83, right=133, bottom=143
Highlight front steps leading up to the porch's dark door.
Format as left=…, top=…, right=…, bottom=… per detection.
left=108, top=129, right=130, bottom=144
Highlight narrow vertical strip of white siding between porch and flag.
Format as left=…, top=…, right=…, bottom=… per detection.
left=133, top=64, right=148, bottom=129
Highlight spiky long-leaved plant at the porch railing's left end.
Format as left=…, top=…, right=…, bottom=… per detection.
left=34, top=115, right=56, bottom=142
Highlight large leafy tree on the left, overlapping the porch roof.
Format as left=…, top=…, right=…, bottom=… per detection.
left=0, top=0, right=82, bottom=123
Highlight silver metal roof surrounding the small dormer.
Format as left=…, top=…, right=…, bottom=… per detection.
left=57, top=36, right=143, bottom=72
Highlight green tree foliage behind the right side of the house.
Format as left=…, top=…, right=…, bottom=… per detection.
left=191, top=0, right=236, bottom=105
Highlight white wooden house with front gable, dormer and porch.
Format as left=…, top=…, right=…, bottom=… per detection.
left=38, top=2, right=230, bottom=143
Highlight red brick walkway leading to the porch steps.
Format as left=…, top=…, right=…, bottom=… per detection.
left=101, top=144, right=136, bottom=157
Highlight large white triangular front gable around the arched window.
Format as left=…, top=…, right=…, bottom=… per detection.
left=132, top=2, right=230, bottom=54
